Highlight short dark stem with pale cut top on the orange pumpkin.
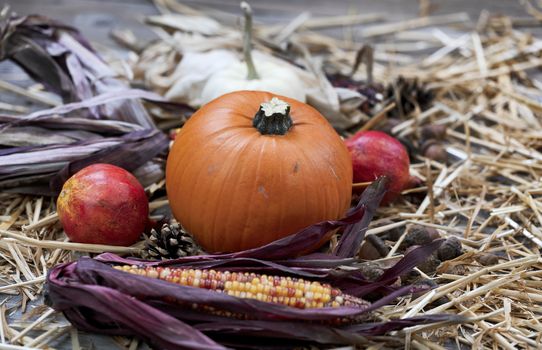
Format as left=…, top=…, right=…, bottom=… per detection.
left=252, top=97, right=293, bottom=135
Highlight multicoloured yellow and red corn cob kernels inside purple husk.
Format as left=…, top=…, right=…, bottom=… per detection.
left=115, top=265, right=368, bottom=309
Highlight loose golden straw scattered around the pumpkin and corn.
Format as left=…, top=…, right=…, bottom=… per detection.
left=0, top=1, right=542, bottom=349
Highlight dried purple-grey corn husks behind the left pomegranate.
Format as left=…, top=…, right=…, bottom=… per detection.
left=0, top=15, right=191, bottom=196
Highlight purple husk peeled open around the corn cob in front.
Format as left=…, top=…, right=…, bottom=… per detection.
left=47, top=180, right=460, bottom=349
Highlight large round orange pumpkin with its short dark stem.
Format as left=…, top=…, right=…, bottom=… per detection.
left=166, top=91, right=352, bottom=252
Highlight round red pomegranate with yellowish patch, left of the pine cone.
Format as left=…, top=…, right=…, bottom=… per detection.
left=57, top=164, right=149, bottom=246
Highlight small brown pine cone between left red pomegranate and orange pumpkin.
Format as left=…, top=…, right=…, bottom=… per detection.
left=141, top=223, right=203, bottom=260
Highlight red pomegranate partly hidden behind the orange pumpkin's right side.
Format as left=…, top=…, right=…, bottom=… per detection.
left=345, top=131, right=411, bottom=204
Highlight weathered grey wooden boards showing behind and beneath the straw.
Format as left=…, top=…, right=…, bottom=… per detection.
left=0, top=0, right=542, bottom=349
